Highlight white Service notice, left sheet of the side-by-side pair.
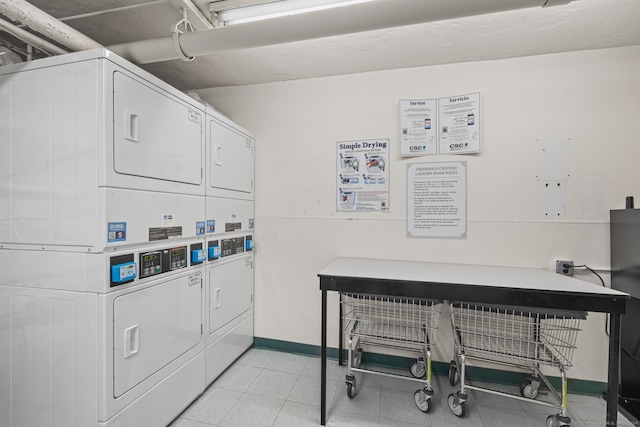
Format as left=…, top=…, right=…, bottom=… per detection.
left=400, top=99, right=438, bottom=156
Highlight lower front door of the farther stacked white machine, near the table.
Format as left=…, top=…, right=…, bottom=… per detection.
left=208, top=256, right=253, bottom=334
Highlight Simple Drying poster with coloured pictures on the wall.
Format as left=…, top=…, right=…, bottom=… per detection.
left=336, top=139, right=390, bottom=211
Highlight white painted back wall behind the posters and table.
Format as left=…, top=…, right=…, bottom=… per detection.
left=200, top=46, right=640, bottom=381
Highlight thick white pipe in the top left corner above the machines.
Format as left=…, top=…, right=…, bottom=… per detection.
left=0, top=0, right=102, bottom=50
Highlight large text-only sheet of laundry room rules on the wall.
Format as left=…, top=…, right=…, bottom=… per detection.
left=407, top=162, right=467, bottom=238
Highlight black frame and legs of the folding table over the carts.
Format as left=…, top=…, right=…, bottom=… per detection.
left=318, top=274, right=626, bottom=426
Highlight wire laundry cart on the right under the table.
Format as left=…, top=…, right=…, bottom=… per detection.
left=447, top=302, right=586, bottom=427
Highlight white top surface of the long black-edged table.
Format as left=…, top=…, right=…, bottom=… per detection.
left=318, top=258, right=628, bottom=298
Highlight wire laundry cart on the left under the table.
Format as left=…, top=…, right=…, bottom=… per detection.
left=340, top=293, right=442, bottom=412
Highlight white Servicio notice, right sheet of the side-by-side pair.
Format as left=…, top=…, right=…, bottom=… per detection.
left=438, top=93, right=481, bottom=154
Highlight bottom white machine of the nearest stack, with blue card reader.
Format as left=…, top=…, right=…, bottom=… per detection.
left=0, top=240, right=205, bottom=427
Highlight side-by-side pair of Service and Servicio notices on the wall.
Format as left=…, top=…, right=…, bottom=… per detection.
left=400, top=92, right=481, bottom=156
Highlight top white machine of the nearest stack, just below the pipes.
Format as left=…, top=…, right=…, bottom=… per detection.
left=0, top=49, right=205, bottom=252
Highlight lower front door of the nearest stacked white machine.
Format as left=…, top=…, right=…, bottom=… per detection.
left=113, top=272, right=202, bottom=398
